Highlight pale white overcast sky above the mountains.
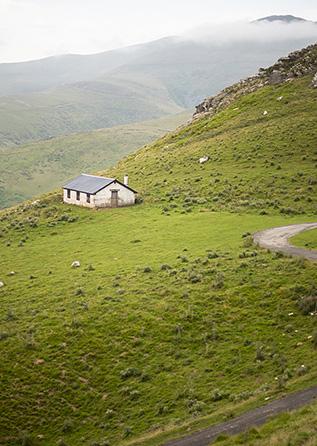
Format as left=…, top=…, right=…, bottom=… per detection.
left=0, top=0, right=317, bottom=62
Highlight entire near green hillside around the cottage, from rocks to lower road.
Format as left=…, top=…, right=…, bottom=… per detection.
left=0, top=74, right=317, bottom=446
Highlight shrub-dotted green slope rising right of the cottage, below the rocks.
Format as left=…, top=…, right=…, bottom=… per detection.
left=110, top=77, right=317, bottom=215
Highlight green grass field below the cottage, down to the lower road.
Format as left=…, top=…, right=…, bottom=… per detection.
left=0, top=204, right=317, bottom=444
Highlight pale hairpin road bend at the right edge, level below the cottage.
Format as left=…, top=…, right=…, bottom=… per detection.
left=253, top=223, right=317, bottom=260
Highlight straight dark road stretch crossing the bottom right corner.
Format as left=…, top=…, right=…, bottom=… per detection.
left=164, top=386, right=317, bottom=446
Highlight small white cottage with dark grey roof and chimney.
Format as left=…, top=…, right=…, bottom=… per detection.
left=63, top=174, right=136, bottom=208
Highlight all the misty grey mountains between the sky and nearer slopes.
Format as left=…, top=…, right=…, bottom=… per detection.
left=0, top=16, right=317, bottom=145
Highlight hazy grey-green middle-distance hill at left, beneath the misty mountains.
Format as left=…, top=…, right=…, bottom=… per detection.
left=0, top=77, right=183, bottom=146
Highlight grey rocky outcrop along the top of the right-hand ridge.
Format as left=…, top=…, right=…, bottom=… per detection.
left=194, top=44, right=317, bottom=118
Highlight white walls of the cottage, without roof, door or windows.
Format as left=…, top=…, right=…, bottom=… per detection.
left=63, top=181, right=135, bottom=208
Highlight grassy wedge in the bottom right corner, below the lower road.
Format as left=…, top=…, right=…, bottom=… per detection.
left=212, top=404, right=317, bottom=446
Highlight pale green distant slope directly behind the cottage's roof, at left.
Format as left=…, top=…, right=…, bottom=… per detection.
left=0, top=112, right=190, bottom=208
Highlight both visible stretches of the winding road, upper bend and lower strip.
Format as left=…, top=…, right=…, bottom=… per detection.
left=160, top=223, right=317, bottom=446
